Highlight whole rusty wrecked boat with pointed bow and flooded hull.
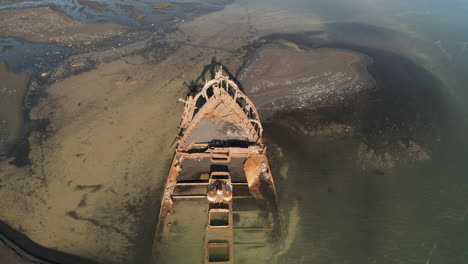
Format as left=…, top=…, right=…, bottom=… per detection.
left=153, top=68, right=282, bottom=264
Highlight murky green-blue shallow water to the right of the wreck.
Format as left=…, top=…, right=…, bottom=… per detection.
left=256, top=1, right=468, bottom=263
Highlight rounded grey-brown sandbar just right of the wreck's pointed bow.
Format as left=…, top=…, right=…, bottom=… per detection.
left=239, top=46, right=375, bottom=118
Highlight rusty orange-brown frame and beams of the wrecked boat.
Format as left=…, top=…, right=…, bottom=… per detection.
left=156, top=68, right=282, bottom=264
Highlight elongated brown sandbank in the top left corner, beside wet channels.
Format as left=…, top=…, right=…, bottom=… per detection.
left=0, top=7, right=125, bottom=45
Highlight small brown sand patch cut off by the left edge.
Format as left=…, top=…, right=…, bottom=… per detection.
left=0, top=61, right=31, bottom=155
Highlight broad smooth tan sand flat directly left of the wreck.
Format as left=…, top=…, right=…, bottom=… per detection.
left=0, top=54, right=186, bottom=263
